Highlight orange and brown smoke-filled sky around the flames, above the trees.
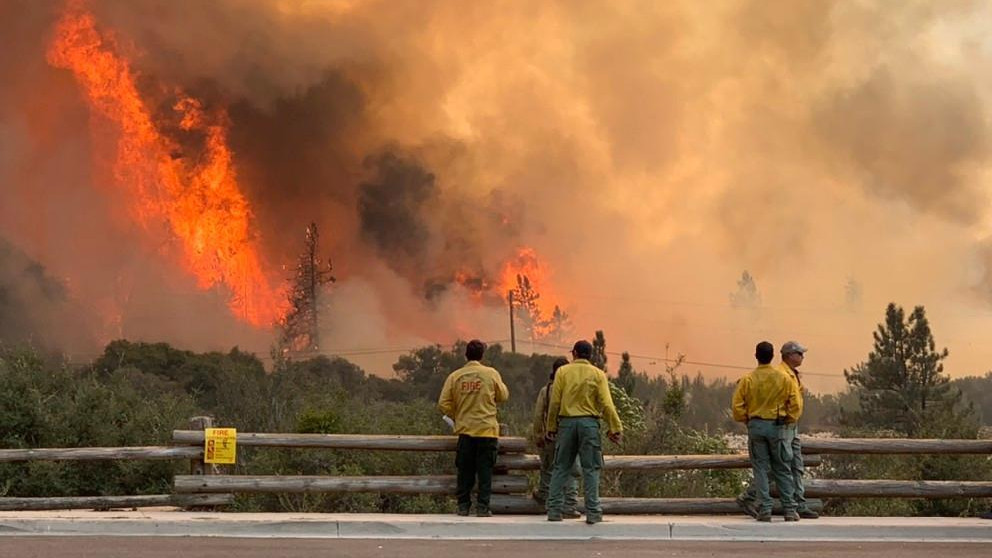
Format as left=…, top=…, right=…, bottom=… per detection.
left=0, top=0, right=992, bottom=391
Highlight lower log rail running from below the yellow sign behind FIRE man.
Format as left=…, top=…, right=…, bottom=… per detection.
left=174, top=475, right=527, bottom=494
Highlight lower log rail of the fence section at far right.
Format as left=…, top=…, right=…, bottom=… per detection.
left=803, top=479, right=992, bottom=498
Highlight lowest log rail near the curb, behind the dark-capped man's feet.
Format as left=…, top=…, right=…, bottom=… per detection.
left=490, top=494, right=823, bottom=515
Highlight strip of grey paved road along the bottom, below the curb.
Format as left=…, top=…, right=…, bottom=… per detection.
left=0, top=536, right=990, bottom=558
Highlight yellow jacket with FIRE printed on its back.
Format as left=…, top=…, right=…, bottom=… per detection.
left=437, top=360, right=510, bottom=438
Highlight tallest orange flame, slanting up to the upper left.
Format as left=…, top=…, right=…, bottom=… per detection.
left=48, top=3, right=287, bottom=326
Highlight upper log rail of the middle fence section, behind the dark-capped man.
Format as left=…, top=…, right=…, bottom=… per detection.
left=496, top=454, right=823, bottom=471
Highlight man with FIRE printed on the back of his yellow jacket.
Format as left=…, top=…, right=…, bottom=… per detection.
left=437, top=339, right=510, bottom=517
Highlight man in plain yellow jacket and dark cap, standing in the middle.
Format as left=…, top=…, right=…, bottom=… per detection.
left=547, top=340, right=623, bottom=524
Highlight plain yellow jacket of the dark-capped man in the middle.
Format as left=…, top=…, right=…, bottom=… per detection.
left=546, top=358, right=623, bottom=440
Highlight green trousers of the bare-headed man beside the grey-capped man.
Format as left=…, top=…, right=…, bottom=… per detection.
left=747, top=419, right=796, bottom=515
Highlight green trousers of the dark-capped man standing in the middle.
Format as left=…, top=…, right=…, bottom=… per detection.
left=548, top=417, right=603, bottom=520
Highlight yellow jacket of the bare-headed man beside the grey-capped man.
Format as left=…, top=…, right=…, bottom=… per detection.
left=732, top=364, right=803, bottom=424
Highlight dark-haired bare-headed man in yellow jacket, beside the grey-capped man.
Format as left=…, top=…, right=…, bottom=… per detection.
left=732, top=341, right=803, bottom=521
